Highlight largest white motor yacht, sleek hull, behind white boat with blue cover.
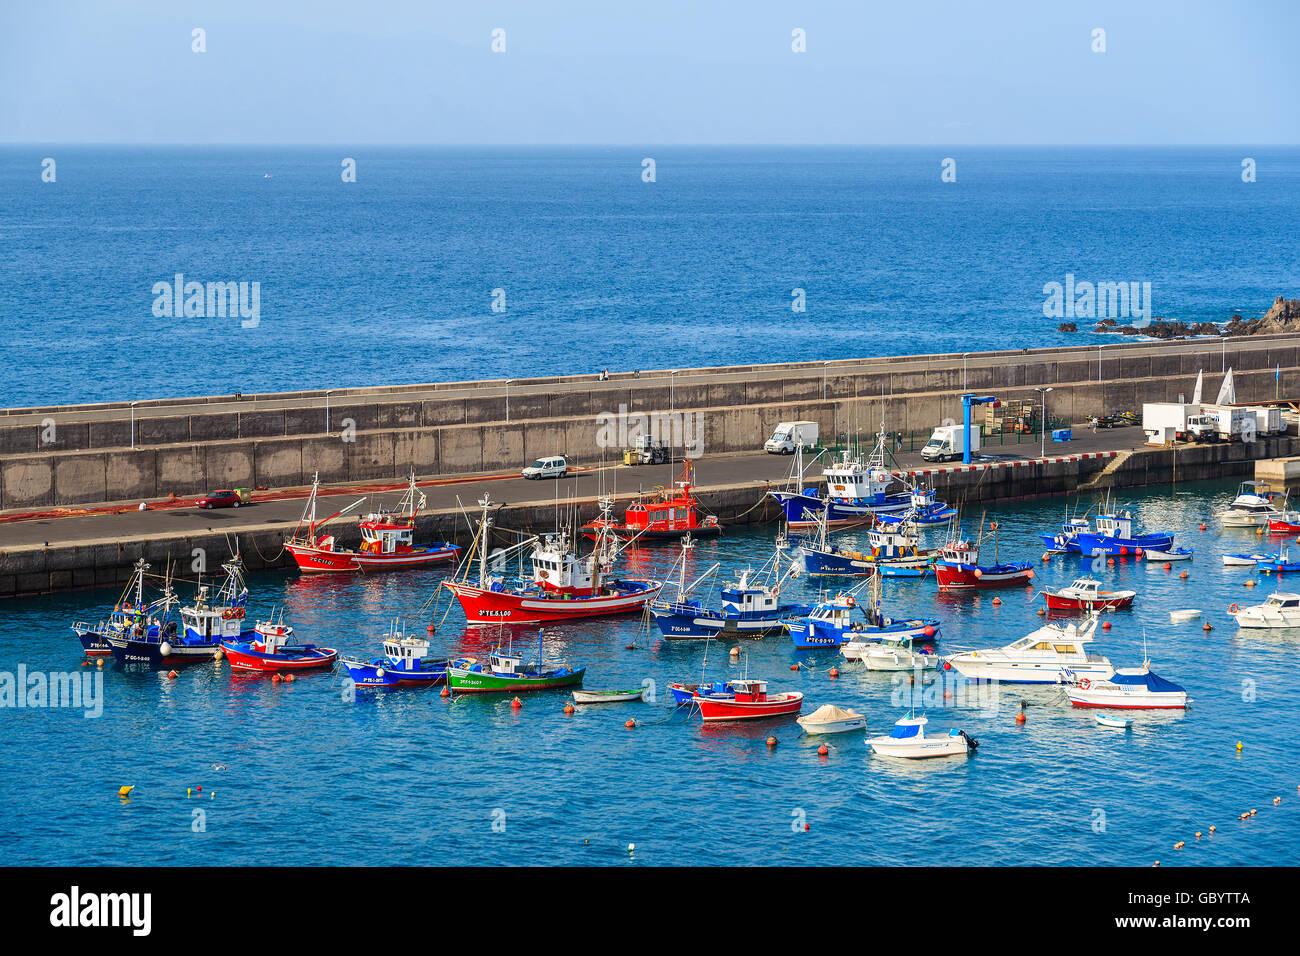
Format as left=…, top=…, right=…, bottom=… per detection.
left=944, top=614, right=1115, bottom=684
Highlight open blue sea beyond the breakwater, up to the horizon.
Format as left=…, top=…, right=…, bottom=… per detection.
left=0, top=146, right=1300, bottom=407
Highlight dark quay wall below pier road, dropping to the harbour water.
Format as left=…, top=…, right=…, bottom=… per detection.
left=0, top=438, right=1300, bottom=597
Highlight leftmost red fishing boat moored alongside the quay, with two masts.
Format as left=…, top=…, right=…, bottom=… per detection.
left=285, top=472, right=460, bottom=574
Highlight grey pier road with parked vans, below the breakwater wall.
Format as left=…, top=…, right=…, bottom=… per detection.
left=0, top=425, right=1145, bottom=550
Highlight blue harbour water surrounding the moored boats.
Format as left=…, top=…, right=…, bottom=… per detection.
left=0, top=484, right=1300, bottom=866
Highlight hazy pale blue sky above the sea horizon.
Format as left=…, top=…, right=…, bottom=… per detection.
left=0, top=0, right=1300, bottom=144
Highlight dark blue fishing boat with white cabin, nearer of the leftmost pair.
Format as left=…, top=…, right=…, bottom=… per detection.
left=108, top=555, right=255, bottom=667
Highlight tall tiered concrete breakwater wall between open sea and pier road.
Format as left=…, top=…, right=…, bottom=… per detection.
left=0, top=337, right=1300, bottom=515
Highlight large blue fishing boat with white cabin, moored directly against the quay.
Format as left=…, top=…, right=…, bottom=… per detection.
left=768, top=421, right=946, bottom=531
